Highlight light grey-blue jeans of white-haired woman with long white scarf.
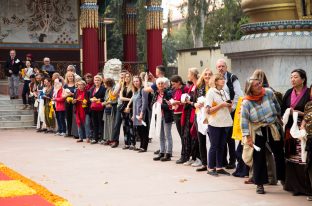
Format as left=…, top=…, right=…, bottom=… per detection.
left=160, top=118, right=172, bottom=154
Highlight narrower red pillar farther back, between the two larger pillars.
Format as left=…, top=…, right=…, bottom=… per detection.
left=123, top=1, right=137, bottom=62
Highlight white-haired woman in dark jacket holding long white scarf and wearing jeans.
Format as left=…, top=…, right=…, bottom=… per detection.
left=149, top=78, right=173, bottom=161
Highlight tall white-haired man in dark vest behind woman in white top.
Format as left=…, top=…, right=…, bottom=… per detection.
left=216, top=59, right=244, bottom=169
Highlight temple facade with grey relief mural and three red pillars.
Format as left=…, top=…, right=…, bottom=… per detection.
left=0, top=0, right=163, bottom=77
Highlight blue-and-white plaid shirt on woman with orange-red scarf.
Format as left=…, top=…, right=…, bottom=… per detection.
left=241, top=88, right=281, bottom=136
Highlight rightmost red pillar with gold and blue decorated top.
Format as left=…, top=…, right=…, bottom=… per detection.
left=146, top=0, right=163, bottom=76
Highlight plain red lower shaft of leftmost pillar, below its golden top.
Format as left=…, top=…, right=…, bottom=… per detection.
left=82, top=28, right=99, bottom=75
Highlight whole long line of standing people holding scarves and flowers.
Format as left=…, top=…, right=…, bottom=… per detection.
left=5, top=50, right=312, bottom=201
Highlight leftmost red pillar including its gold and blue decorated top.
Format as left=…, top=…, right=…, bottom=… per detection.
left=80, top=0, right=99, bottom=75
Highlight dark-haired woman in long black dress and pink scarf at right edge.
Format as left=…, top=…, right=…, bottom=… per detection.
left=282, top=69, right=311, bottom=195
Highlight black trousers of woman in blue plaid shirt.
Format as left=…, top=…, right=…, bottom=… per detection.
left=253, top=127, right=285, bottom=185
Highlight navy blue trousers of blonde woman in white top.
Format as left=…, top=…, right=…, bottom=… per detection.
left=208, top=125, right=229, bottom=169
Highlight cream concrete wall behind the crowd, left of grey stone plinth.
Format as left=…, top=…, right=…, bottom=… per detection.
left=178, top=47, right=231, bottom=81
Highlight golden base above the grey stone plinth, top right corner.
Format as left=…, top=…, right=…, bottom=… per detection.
left=241, top=0, right=312, bottom=22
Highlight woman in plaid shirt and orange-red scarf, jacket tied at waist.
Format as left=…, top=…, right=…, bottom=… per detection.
left=241, top=77, right=284, bottom=194
